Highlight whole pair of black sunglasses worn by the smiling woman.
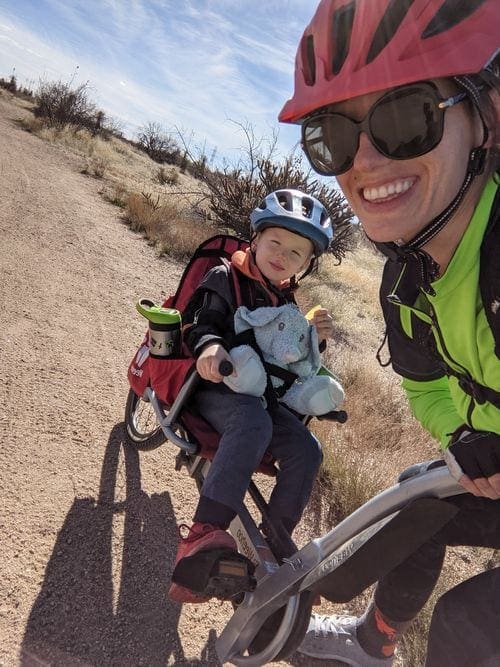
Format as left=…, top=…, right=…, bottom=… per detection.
left=302, top=81, right=466, bottom=176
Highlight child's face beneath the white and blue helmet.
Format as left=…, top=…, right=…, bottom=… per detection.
left=252, top=227, right=314, bottom=285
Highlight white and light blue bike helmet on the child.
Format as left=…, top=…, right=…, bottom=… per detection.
left=250, top=189, right=333, bottom=257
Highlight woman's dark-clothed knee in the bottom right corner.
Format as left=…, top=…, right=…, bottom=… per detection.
left=425, top=567, right=500, bottom=667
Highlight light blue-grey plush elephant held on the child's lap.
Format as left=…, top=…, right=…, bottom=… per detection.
left=224, top=304, right=344, bottom=415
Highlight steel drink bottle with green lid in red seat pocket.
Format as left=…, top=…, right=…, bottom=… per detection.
left=136, top=299, right=182, bottom=359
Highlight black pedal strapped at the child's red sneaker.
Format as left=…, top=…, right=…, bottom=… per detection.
left=172, top=549, right=257, bottom=600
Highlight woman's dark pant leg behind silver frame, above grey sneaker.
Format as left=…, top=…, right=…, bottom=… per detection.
left=375, top=493, right=500, bottom=624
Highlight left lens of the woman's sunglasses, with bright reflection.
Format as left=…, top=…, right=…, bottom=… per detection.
left=302, top=114, right=359, bottom=176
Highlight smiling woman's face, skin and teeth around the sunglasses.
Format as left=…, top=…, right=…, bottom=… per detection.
left=332, top=80, right=482, bottom=242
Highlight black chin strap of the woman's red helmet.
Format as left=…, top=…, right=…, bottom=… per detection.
left=374, top=147, right=486, bottom=294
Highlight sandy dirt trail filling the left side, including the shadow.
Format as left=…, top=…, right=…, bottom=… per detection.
left=0, top=90, right=336, bottom=667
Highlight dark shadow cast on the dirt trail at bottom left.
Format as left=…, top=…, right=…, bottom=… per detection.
left=19, top=424, right=219, bottom=667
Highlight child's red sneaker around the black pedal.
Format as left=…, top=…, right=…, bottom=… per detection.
left=168, top=523, right=238, bottom=603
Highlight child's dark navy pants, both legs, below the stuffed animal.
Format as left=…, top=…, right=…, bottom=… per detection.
left=194, top=385, right=322, bottom=530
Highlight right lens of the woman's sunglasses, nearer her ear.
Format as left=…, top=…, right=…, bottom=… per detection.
left=370, top=88, right=444, bottom=160
